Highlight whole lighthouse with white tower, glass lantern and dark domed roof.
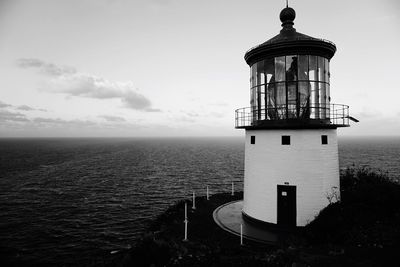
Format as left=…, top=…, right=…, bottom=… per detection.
left=235, top=7, right=352, bottom=227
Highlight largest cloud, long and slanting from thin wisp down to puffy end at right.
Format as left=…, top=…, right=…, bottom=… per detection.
left=18, top=58, right=160, bottom=112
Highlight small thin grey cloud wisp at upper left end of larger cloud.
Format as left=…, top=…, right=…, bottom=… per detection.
left=17, top=58, right=76, bottom=76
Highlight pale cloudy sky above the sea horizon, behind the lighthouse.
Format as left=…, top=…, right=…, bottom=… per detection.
left=0, top=0, right=400, bottom=137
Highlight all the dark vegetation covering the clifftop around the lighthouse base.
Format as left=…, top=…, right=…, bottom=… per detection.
left=111, top=168, right=400, bottom=266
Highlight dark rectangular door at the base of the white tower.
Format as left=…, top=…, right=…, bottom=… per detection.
left=278, top=185, right=297, bottom=226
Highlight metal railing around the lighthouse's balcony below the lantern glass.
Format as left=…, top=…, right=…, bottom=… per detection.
left=235, top=104, right=349, bottom=128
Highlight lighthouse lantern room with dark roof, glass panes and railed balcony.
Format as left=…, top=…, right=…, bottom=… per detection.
left=236, top=7, right=349, bottom=129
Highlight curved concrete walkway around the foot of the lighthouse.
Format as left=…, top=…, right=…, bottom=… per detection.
left=213, top=200, right=287, bottom=245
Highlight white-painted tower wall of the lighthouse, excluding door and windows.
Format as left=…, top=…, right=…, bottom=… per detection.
left=243, top=129, right=339, bottom=226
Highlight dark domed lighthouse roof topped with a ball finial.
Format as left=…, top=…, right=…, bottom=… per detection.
left=244, top=7, right=336, bottom=66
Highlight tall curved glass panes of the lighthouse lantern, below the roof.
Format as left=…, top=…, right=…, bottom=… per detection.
left=250, top=55, right=330, bottom=120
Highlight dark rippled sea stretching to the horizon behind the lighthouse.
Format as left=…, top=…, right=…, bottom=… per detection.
left=0, top=137, right=400, bottom=266
